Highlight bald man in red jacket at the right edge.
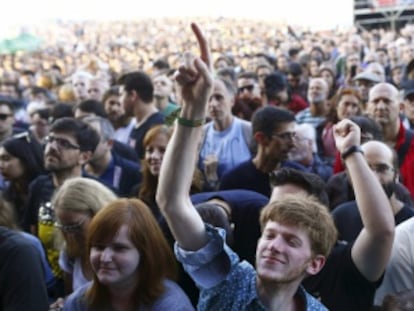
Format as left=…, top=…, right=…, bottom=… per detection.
left=367, top=83, right=414, bottom=197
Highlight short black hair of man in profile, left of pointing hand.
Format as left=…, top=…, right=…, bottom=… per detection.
left=118, top=71, right=154, bottom=103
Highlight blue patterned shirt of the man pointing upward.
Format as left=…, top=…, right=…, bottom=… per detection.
left=175, top=225, right=328, bottom=311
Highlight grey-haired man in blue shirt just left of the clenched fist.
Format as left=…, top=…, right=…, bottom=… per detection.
left=282, top=123, right=332, bottom=181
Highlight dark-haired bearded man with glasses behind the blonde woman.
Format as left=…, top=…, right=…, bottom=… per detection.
left=24, top=118, right=99, bottom=299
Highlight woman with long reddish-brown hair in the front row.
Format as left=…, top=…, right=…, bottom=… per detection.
left=64, top=199, right=193, bottom=311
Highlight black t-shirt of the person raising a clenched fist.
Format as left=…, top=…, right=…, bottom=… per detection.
left=303, top=242, right=382, bottom=311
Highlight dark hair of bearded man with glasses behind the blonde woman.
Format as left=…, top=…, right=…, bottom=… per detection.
left=50, top=118, right=100, bottom=152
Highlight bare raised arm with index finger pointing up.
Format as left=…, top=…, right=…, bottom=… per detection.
left=156, top=24, right=213, bottom=250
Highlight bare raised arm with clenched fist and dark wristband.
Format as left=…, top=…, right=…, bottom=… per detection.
left=334, top=120, right=395, bottom=282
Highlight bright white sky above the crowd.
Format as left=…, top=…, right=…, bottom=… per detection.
left=0, top=0, right=353, bottom=32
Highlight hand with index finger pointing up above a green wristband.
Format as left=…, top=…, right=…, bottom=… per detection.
left=175, top=23, right=213, bottom=119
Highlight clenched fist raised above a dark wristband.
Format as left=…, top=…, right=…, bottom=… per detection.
left=334, top=119, right=361, bottom=153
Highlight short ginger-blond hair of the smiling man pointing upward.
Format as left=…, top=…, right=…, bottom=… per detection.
left=260, top=194, right=338, bottom=257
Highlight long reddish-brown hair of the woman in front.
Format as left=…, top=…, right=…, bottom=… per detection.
left=86, top=199, right=176, bottom=310
